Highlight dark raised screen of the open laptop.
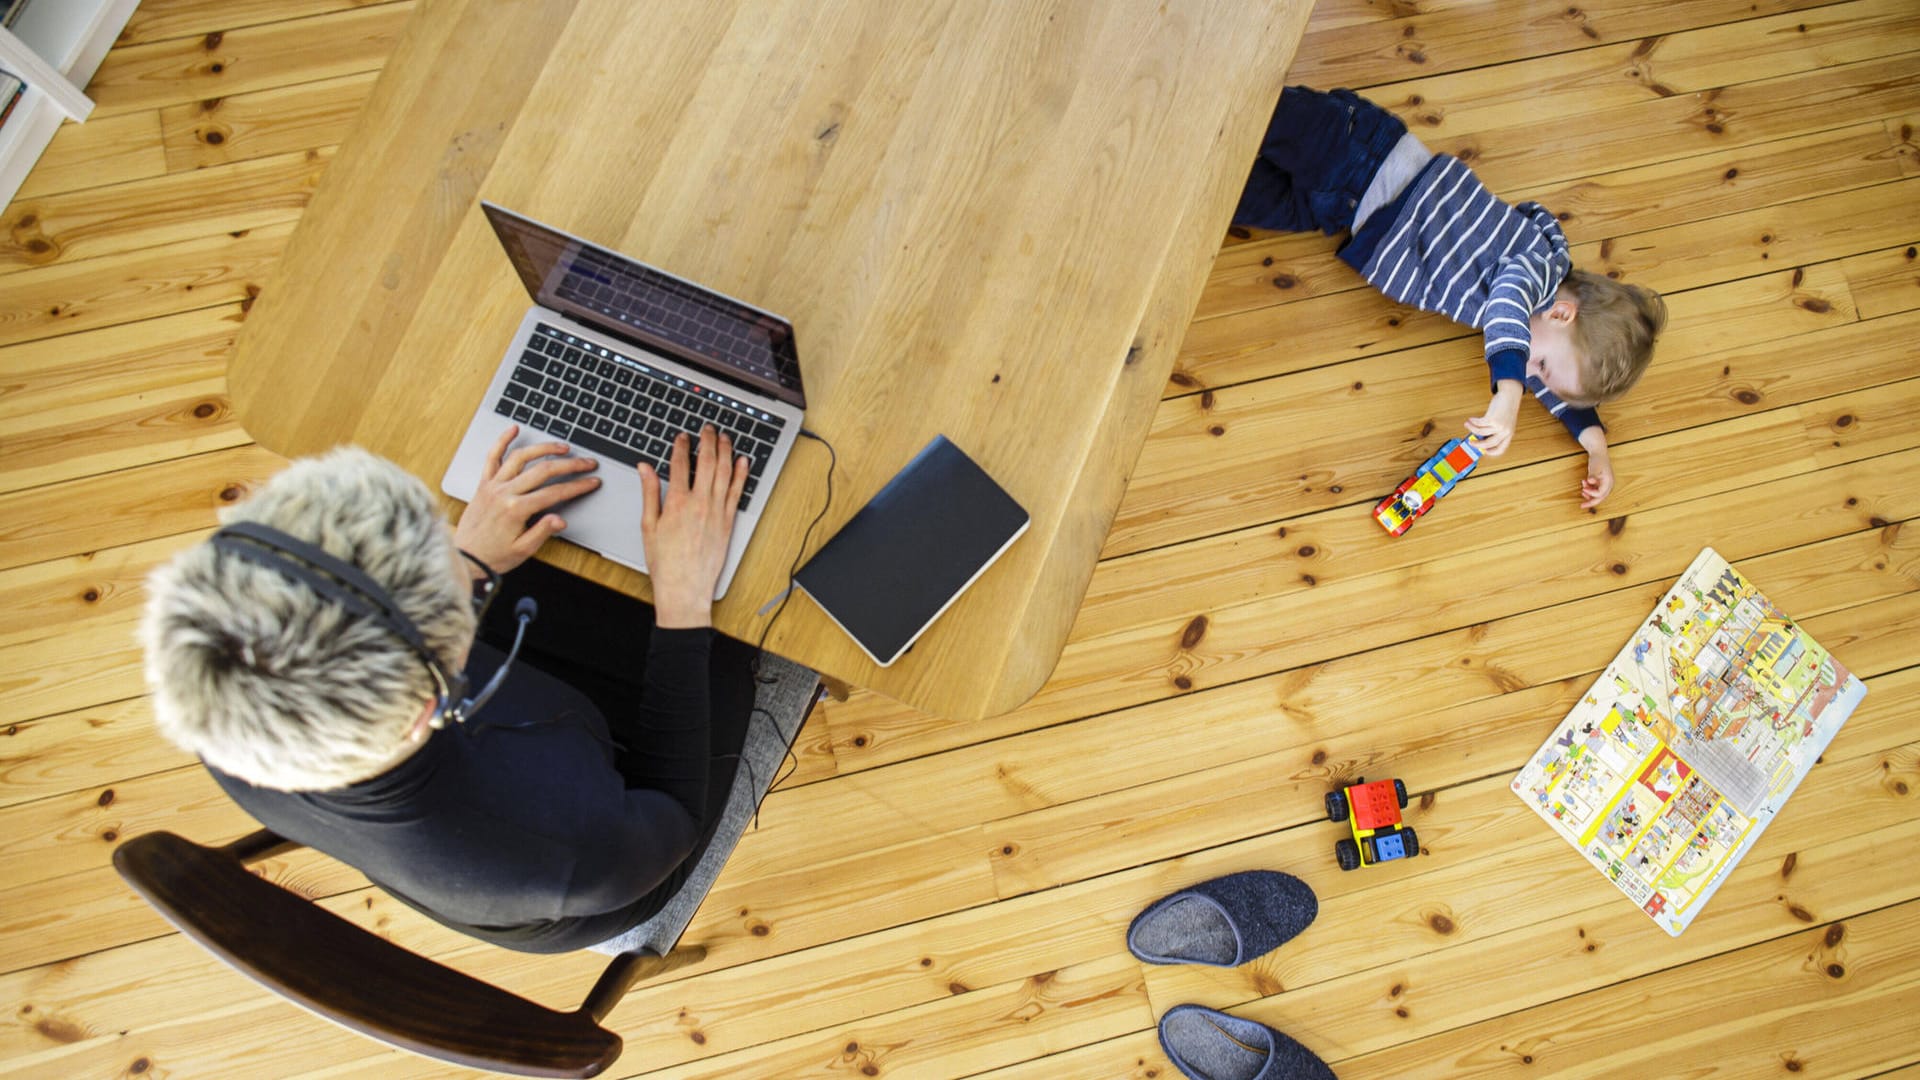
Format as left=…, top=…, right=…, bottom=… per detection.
left=480, top=202, right=806, bottom=409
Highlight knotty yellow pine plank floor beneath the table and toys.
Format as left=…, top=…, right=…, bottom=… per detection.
left=0, top=0, right=1920, bottom=1080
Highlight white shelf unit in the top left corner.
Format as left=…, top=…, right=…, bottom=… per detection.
left=0, top=0, right=140, bottom=208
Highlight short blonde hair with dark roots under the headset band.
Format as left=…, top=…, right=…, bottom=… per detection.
left=140, top=448, right=474, bottom=792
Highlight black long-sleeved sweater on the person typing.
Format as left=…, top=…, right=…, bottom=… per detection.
left=213, top=628, right=724, bottom=951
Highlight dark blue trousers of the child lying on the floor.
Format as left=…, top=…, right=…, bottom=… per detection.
left=1233, top=86, right=1407, bottom=236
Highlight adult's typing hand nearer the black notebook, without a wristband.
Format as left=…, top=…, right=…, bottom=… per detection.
left=637, top=425, right=747, bottom=630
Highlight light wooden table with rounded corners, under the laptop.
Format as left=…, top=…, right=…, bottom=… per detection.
left=228, top=0, right=1309, bottom=717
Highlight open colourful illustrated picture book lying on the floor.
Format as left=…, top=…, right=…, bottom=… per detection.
left=1513, top=548, right=1866, bottom=936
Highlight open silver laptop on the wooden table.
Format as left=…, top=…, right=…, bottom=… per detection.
left=440, top=202, right=806, bottom=600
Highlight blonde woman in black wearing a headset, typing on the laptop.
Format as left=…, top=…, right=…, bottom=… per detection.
left=142, top=427, right=753, bottom=951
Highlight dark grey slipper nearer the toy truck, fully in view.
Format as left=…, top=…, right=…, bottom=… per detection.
left=1127, top=871, right=1319, bottom=967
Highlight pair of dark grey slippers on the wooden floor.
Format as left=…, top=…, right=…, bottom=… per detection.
left=1127, top=871, right=1334, bottom=1080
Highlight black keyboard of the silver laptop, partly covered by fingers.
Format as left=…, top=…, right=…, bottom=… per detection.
left=493, top=323, right=787, bottom=509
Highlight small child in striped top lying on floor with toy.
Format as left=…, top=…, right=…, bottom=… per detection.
left=1233, top=86, right=1667, bottom=509
